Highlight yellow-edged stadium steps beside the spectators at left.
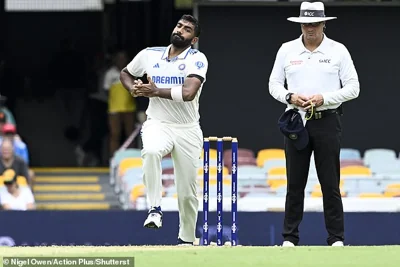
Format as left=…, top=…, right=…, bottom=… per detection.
left=33, top=168, right=120, bottom=210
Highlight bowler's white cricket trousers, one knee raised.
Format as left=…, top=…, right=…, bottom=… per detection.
left=142, top=120, right=203, bottom=242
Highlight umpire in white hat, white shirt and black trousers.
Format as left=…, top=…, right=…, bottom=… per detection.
left=269, top=2, right=360, bottom=246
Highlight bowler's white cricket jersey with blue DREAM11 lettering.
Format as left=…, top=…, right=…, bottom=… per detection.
left=127, top=45, right=208, bottom=124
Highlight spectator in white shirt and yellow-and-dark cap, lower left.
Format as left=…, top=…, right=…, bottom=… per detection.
left=0, top=169, right=35, bottom=210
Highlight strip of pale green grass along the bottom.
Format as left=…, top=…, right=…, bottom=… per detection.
left=0, top=246, right=400, bottom=267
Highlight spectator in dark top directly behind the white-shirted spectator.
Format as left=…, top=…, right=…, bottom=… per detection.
left=0, top=138, right=32, bottom=186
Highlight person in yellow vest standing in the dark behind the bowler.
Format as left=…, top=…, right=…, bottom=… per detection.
left=104, top=51, right=136, bottom=157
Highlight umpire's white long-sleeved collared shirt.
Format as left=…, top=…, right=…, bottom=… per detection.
left=269, top=35, right=360, bottom=120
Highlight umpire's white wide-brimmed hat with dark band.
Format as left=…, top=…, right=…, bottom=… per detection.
left=287, top=2, right=337, bottom=23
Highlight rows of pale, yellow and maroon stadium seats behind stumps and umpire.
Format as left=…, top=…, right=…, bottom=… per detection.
left=109, top=148, right=400, bottom=210
